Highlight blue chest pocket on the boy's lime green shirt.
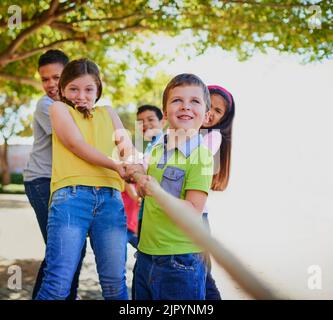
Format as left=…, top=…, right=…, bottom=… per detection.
left=161, top=166, right=185, bottom=198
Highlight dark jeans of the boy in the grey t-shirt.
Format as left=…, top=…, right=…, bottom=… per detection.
left=24, top=178, right=86, bottom=300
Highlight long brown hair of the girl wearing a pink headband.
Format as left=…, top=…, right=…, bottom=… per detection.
left=202, top=85, right=235, bottom=191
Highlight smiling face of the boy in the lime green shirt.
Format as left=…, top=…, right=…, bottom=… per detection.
left=164, top=85, right=206, bottom=130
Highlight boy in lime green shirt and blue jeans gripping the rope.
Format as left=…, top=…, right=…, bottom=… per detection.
left=127, top=74, right=213, bottom=300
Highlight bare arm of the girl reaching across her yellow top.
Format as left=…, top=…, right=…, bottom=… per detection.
left=50, top=101, right=124, bottom=177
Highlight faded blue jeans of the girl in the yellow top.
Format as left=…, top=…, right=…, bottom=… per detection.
left=36, top=186, right=128, bottom=300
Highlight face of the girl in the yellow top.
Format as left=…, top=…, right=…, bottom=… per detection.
left=62, top=74, right=98, bottom=110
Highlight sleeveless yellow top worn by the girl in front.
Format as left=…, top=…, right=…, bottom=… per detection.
left=51, top=106, right=124, bottom=198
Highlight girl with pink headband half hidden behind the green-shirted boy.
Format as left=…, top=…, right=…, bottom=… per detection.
left=202, top=85, right=235, bottom=300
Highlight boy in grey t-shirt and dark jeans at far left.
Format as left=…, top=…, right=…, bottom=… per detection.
left=24, top=49, right=86, bottom=300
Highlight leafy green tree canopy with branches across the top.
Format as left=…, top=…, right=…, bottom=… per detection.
left=0, top=0, right=333, bottom=94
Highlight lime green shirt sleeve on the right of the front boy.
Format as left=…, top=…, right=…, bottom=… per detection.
left=184, top=146, right=214, bottom=194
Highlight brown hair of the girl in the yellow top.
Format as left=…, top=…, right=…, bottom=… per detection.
left=59, top=58, right=103, bottom=118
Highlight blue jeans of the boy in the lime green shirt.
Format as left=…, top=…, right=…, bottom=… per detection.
left=134, top=252, right=206, bottom=300
